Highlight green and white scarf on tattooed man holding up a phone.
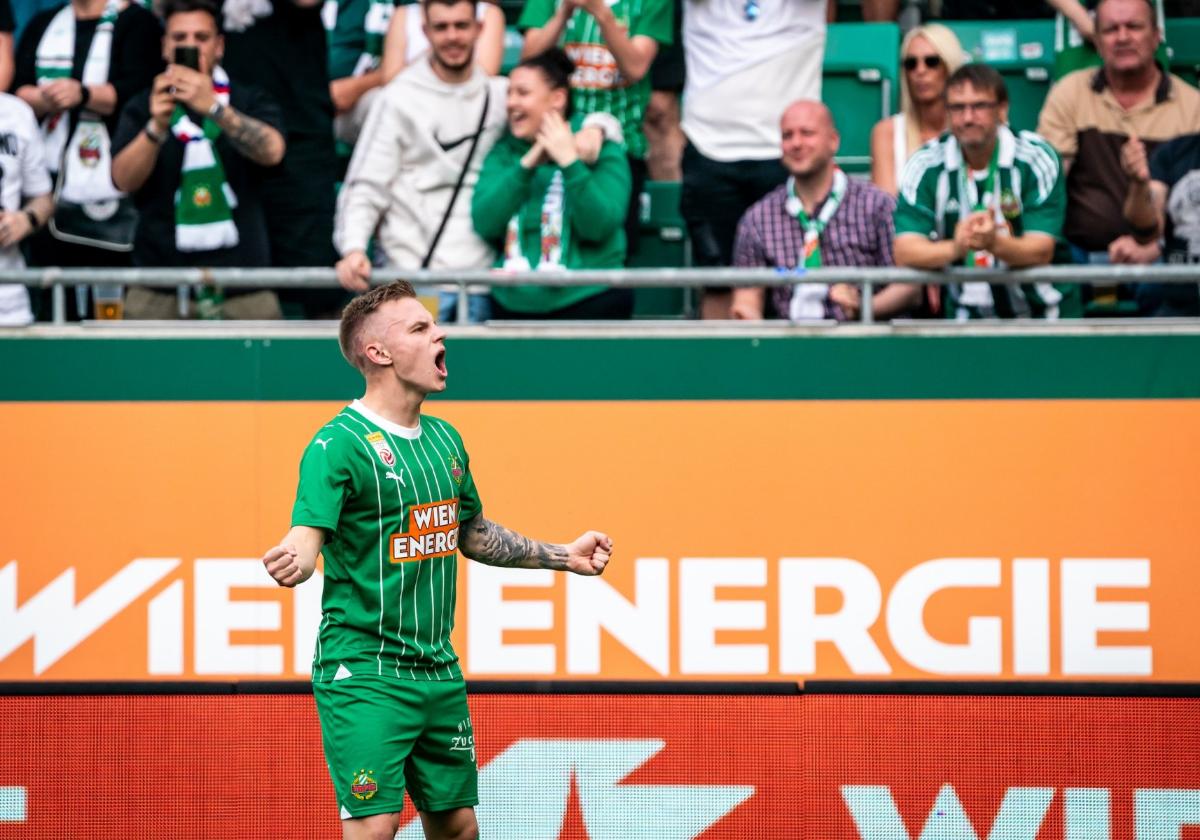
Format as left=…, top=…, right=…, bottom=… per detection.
left=170, top=67, right=238, bottom=251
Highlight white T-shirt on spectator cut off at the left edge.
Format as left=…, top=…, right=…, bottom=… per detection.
left=0, top=94, right=54, bottom=326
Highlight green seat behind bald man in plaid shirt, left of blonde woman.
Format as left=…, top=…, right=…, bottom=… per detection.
left=821, top=23, right=900, bottom=173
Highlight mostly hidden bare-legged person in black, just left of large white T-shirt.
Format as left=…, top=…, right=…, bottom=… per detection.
left=642, top=0, right=686, bottom=181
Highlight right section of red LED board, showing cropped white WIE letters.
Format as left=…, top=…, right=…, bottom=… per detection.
left=802, top=695, right=1200, bottom=840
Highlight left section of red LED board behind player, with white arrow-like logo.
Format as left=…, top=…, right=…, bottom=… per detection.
left=0, top=695, right=800, bottom=840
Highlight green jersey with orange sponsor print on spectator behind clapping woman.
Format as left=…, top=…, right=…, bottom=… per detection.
left=517, top=0, right=674, bottom=158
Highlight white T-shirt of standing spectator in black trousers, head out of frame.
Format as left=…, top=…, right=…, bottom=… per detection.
left=683, top=0, right=826, bottom=161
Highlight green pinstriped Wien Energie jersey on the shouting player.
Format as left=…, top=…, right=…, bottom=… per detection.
left=292, top=401, right=482, bottom=682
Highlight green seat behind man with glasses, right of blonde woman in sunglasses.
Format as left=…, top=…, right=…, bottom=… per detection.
left=943, top=20, right=1054, bottom=131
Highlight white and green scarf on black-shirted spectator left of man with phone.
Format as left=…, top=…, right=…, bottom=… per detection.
left=35, top=0, right=121, bottom=172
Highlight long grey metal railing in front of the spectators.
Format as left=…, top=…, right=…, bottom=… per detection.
left=0, top=265, right=1200, bottom=324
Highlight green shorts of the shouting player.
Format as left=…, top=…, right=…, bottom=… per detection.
left=312, top=676, right=479, bottom=820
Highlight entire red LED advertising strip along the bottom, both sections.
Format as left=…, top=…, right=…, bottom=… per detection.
left=0, top=694, right=1200, bottom=840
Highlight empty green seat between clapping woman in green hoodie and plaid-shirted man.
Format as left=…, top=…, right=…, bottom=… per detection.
left=629, top=181, right=689, bottom=319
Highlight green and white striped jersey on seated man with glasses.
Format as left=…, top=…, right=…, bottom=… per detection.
left=894, top=125, right=1080, bottom=319
